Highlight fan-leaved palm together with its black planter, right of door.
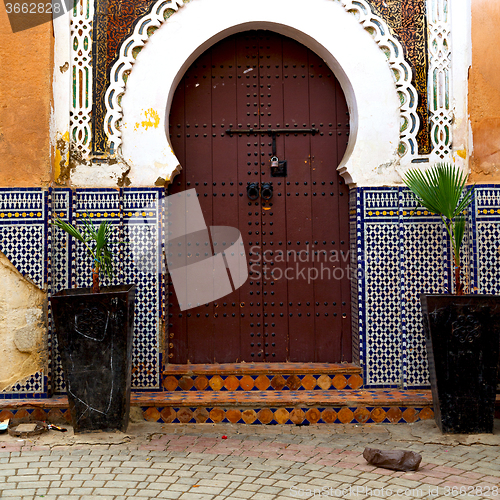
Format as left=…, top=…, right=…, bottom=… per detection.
left=404, top=163, right=500, bottom=434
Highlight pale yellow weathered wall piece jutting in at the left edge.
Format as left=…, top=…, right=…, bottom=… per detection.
left=0, top=252, right=47, bottom=391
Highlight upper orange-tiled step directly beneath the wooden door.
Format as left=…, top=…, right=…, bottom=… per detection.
left=163, top=363, right=363, bottom=392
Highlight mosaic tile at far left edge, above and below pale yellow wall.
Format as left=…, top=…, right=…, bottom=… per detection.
left=0, top=188, right=48, bottom=399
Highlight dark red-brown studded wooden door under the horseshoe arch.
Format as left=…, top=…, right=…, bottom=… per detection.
left=166, top=31, right=351, bottom=363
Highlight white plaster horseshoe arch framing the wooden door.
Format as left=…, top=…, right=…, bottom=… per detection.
left=120, top=0, right=410, bottom=186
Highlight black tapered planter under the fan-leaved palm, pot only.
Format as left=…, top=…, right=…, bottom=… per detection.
left=420, top=294, right=500, bottom=434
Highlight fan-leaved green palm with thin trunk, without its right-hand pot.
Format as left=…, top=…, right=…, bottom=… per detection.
left=403, top=163, right=474, bottom=295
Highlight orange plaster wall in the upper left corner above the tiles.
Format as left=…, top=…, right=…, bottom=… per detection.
left=0, top=6, right=53, bottom=187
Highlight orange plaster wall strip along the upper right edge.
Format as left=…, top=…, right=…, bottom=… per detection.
left=469, top=0, right=500, bottom=183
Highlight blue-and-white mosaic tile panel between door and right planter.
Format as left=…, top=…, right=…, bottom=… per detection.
left=357, top=188, right=454, bottom=388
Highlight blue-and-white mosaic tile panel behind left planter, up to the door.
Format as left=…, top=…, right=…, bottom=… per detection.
left=51, top=188, right=163, bottom=393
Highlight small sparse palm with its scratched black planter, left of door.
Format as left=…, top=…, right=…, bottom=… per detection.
left=51, top=215, right=135, bottom=433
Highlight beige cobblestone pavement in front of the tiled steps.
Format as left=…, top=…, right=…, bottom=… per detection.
left=0, top=421, right=500, bottom=500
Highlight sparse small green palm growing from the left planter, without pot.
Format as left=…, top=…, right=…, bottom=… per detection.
left=52, top=214, right=113, bottom=293
